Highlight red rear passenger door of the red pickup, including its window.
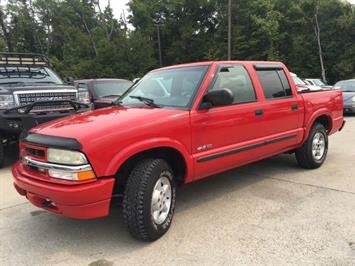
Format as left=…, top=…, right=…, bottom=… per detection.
left=254, top=65, right=304, bottom=145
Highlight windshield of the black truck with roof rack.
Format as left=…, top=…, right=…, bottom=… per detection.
left=0, top=66, right=63, bottom=86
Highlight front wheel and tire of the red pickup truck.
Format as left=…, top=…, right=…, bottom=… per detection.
left=123, top=159, right=176, bottom=241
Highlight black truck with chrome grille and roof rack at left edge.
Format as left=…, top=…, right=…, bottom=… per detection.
left=0, top=53, right=91, bottom=167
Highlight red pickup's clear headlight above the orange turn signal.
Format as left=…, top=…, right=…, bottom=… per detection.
left=47, top=148, right=88, bottom=165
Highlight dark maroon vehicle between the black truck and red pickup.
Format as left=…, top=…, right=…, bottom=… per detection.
left=75, top=79, right=133, bottom=109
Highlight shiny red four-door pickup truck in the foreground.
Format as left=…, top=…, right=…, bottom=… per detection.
left=12, top=61, right=344, bottom=241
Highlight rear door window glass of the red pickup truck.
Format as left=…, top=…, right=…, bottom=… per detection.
left=257, top=70, right=292, bottom=99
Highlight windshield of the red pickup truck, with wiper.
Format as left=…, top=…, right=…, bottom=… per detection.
left=120, top=66, right=208, bottom=108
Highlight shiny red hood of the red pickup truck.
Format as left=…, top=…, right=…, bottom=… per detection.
left=31, top=107, right=187, bottom=143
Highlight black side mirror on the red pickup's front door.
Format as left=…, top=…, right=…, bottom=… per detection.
left=201, top=89, right=234, bottom=109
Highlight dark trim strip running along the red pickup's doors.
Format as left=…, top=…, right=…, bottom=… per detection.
left=197, top=134, right=297, bottom=163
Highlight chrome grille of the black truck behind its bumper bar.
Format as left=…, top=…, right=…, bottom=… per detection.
left=16, top=91, right=76, bottom=112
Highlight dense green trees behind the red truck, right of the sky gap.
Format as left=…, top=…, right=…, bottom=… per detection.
left=129, top=0, right=355, bottom=83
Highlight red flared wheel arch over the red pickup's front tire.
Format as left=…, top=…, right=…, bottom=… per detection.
left=105, top=138, right=194, bottom=179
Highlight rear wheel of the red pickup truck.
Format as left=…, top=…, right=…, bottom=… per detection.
left=296, top=123, right=328, bottom=169
